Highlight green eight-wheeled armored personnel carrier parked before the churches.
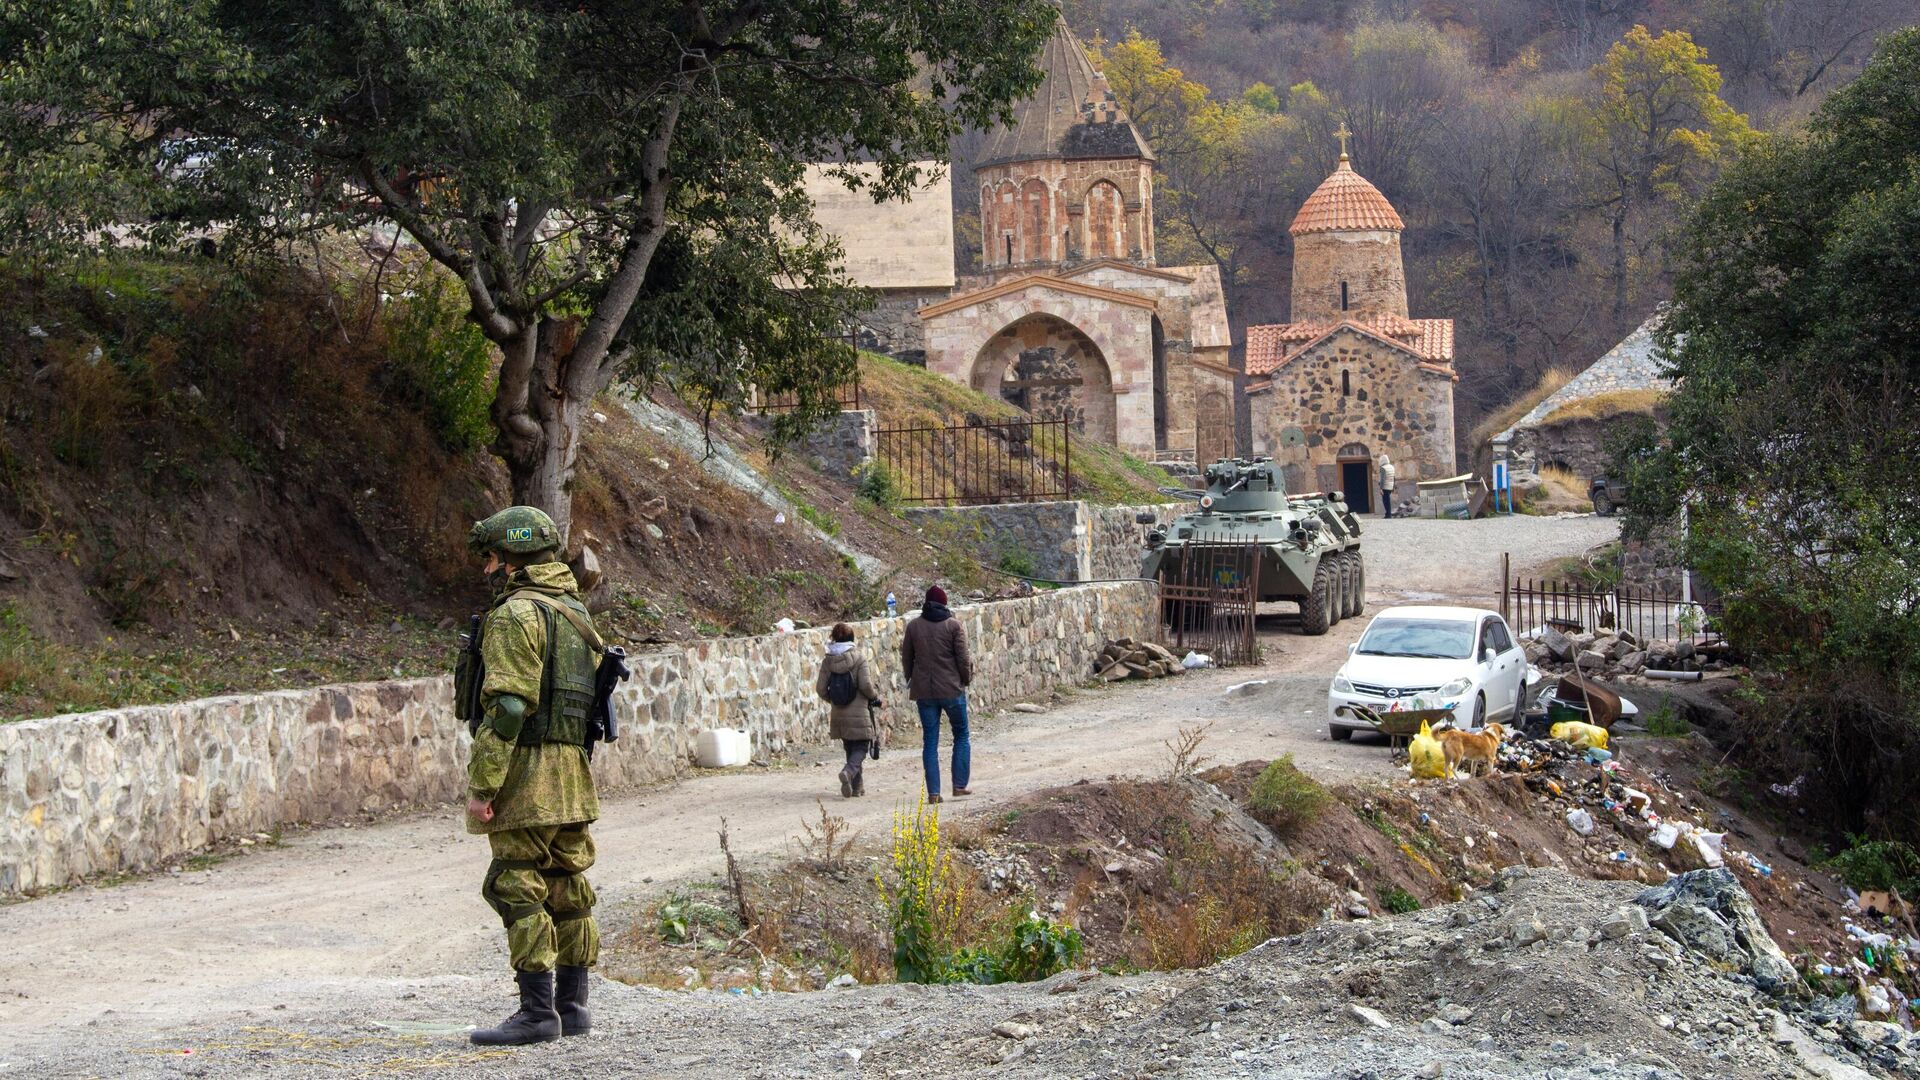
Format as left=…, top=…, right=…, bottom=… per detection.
left=1140, top=457, right=1367, bottom=634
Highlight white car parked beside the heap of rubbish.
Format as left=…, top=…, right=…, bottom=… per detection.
left=1327, top=607, right=1528, bottom=740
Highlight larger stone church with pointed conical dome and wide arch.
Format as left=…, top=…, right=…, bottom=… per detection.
left=916, top=19, right=1235, bottom=461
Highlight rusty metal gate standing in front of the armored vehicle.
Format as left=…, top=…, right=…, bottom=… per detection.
left=1160, top=536, right=1261, bottom=667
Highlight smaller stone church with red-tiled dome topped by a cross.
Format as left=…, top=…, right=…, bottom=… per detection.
left=1246, top=141, right=1459, bottom=513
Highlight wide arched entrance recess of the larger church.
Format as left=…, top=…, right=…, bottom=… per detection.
left=970, top=313, right=1117, bottom=444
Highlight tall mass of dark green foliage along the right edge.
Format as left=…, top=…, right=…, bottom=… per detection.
left=1634, top=29, right=1920, bottom=836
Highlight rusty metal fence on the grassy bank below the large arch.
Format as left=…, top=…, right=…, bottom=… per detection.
left=874, top=421, right=1073, bottom=505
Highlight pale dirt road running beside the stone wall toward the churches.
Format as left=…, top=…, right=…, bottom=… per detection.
left=0, top=519, right=1615, bottom=1068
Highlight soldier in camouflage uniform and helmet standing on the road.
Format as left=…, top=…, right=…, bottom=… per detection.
left=467, top=505, right=603, bottom=1045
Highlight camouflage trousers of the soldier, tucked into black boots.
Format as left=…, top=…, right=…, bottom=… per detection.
left=480, top=821, right=599, bottom=970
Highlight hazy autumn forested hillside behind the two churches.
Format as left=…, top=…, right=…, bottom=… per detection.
left=954, top=0, right=1914, bottom=443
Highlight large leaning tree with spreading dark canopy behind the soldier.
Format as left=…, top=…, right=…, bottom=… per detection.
left=0, top=0, right=1054, bottom=528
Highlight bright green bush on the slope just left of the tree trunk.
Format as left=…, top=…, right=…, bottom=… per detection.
left=386, top=273, right=493, bottom=454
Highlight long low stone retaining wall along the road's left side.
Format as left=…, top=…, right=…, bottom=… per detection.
left=0, top=584, right=1156, bottom=896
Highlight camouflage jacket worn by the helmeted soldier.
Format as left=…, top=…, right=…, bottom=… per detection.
left=467, top=563, right=599, bottom=832
